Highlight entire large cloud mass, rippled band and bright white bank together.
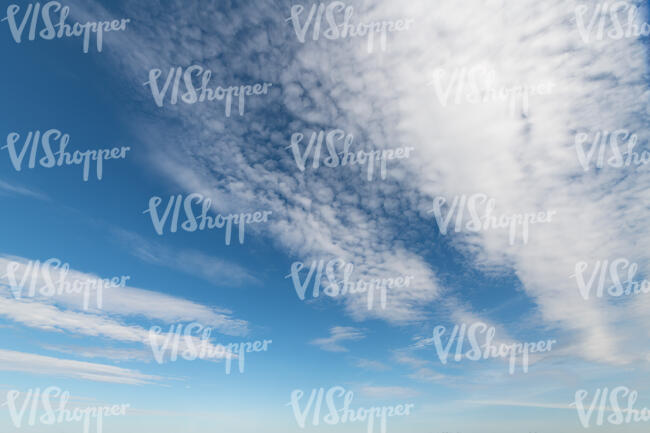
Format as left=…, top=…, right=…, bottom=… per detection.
left=73, top=0, right=650, bottom=365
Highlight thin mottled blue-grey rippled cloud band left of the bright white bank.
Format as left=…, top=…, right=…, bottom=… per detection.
left=68, top=3, right=439, bottom=322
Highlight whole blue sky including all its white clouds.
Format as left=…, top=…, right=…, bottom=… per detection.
left=0, top=0, right=650, bottom=433
